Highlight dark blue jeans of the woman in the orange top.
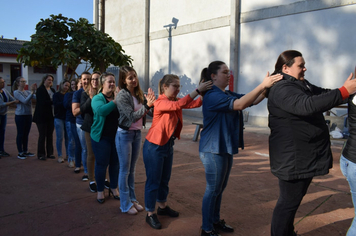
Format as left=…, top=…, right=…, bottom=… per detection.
left=143, top=138, right=174, bottom=212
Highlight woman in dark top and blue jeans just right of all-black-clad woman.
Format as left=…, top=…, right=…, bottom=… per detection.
left=53, top=80, right=70, bottom=163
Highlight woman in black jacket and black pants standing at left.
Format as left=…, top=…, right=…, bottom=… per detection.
left=33, top=75, right=56, bottom=160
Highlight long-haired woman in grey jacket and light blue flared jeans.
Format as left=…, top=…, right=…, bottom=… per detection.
left=115, top=66, right=155, bottom=215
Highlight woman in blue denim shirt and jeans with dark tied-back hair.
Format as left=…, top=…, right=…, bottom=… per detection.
left=199, top=61, right=282, bottom=235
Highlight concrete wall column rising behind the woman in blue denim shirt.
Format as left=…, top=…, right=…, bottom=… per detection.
left=230, top=0, right=241, bottom=92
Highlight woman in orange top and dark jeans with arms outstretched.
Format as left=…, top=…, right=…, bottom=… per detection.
left=143, top=74, right=212, bottom=229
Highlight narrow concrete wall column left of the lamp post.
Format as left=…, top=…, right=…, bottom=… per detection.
left=143, top=0, right=150, bottom=91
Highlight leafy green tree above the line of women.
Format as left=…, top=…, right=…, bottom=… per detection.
left=17, top=14, right=132, bottom=77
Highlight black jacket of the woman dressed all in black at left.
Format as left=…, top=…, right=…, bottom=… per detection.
left=32, top=85, right=56, bottom=124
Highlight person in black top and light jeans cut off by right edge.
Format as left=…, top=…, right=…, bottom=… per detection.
left=340, top=95, right=356, bottom=236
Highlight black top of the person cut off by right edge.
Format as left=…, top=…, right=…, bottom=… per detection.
left=342, top=95, right=356, bottom=163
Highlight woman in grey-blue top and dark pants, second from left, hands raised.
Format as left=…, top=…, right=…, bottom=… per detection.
left=12, top=76, right=37, bottom=160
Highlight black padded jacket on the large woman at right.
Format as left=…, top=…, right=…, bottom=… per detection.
left=268, top=74, right=343, bottom=180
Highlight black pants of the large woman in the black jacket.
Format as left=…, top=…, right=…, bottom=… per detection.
left=271, top=178, right=313, bottom=236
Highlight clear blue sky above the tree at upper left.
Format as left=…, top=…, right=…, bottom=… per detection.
left=0, top=0, right=93, bottom=41
